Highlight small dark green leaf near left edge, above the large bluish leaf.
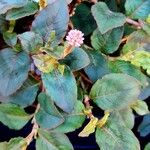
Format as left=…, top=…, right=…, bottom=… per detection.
left=3, top=31, right=17, bottom=46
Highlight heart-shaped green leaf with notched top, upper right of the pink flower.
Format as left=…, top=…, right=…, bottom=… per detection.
left=92, top=2, right=126, bottom=34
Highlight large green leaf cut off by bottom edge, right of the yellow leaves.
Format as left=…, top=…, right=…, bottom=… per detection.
left=96, top=113, right=140, bottom=150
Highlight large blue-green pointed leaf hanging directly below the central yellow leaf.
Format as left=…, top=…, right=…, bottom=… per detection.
left=42, top=67, right=77, bottom=113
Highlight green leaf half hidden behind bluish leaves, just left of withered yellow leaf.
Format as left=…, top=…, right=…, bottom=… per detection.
left=54, top=101, right=85, bottom=133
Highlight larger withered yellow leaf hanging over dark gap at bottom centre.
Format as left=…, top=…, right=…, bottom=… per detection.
left=79, top=117, right=98, bottom=137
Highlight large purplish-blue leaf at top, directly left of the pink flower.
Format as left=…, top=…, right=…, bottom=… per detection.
left=32, top=0, right=69, bottom=42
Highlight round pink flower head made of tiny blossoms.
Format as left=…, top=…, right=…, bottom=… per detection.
left=66, top=29, right=84, bottom=47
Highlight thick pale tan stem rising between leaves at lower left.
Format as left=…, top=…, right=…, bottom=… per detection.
left=25, top=104, right=40, bottom=145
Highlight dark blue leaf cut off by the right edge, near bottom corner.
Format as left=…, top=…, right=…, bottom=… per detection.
left=138, top=114, right=150, bottom=137
